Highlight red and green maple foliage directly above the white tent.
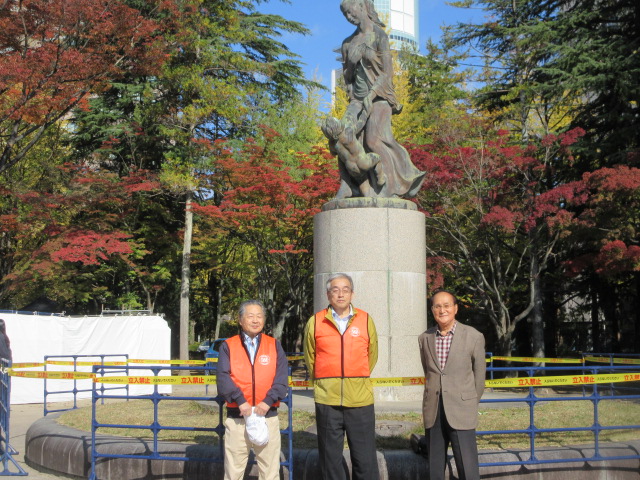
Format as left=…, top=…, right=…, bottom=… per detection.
left=3, top=166, right=167, bottom=313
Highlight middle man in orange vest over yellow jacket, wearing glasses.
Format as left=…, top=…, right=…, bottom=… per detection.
left=304, top=273, right=378, bottom=480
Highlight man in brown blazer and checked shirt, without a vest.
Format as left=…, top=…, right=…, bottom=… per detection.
left=418, top=291, right=486, bottom=480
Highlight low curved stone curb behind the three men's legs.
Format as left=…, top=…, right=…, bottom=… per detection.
left=25, top=414, right=640, bottom=480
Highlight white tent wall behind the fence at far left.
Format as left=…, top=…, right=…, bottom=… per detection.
left=0, top=313, right=171, bottom=404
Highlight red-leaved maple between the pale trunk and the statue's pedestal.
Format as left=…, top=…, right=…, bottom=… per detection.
left=195, top=127, right=338, bottom=347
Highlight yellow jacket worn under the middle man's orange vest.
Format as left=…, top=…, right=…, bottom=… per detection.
left=304, top=308, right=378, bottom=407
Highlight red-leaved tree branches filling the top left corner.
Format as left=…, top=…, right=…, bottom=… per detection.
left=0, top=0, right=171, bottom=172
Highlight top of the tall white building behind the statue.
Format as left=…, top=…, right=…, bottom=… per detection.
left=373, top=0, right=420, bottom=50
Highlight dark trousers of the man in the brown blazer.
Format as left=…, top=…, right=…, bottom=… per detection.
left=426, top=398, right=480, bottom=480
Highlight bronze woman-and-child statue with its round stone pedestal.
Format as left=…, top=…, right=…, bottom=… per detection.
left=314, top=0, right=427, bottom=400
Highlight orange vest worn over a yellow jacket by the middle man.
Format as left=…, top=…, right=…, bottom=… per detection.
left=314, top=308, right=371, bottom=379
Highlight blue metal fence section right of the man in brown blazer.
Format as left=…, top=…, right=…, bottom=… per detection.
left=477, top=365, right=640, bottom=466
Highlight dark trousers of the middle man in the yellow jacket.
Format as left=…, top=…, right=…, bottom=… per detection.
left=316, top=403, right=379, bottom=480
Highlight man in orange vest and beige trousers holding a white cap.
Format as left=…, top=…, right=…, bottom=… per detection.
left=217, top=300, right=289, bottom=480
